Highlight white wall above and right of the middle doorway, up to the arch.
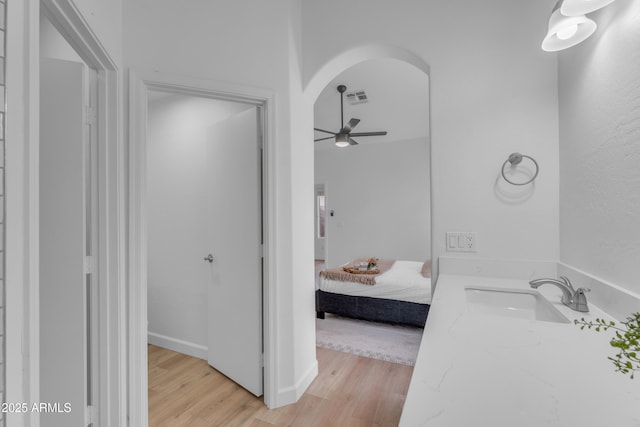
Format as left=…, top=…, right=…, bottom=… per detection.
left=124, top=0, right=317, bottom=406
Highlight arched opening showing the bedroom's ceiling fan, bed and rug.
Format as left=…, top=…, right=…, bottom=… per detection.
left=314, top=58, right=432, bottom=364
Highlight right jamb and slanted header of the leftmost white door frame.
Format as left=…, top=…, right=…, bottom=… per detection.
left=38, top=0, right=126, bottom=425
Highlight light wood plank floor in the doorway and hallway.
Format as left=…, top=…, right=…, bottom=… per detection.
left=148, top=345, right=413, bottom=427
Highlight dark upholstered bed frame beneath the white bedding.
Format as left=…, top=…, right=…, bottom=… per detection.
left=316, top=290, right=430, bottom=328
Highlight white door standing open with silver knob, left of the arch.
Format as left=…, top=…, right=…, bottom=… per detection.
left=206, top=108, right=263, bottom=396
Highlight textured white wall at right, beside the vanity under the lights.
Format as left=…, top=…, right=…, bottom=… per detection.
left=559, top=1, right=640, bottom=294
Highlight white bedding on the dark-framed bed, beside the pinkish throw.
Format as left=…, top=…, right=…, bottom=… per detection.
left=319, top=260, right=431, bottom=304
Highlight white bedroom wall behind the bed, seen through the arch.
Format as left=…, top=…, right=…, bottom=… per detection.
left=315, top=138, right=431, bottom=267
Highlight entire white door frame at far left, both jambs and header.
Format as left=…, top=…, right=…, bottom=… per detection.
left=5, top=0, right=122, bottom=426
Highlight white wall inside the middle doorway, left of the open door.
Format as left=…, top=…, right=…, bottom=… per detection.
left=147, top=95, right=251, bottom=358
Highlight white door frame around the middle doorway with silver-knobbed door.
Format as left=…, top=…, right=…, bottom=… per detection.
left=128, top=70, right=277, bottom=426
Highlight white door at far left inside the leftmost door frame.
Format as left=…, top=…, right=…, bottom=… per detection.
left=39, top=60, right=95, bottom=427
